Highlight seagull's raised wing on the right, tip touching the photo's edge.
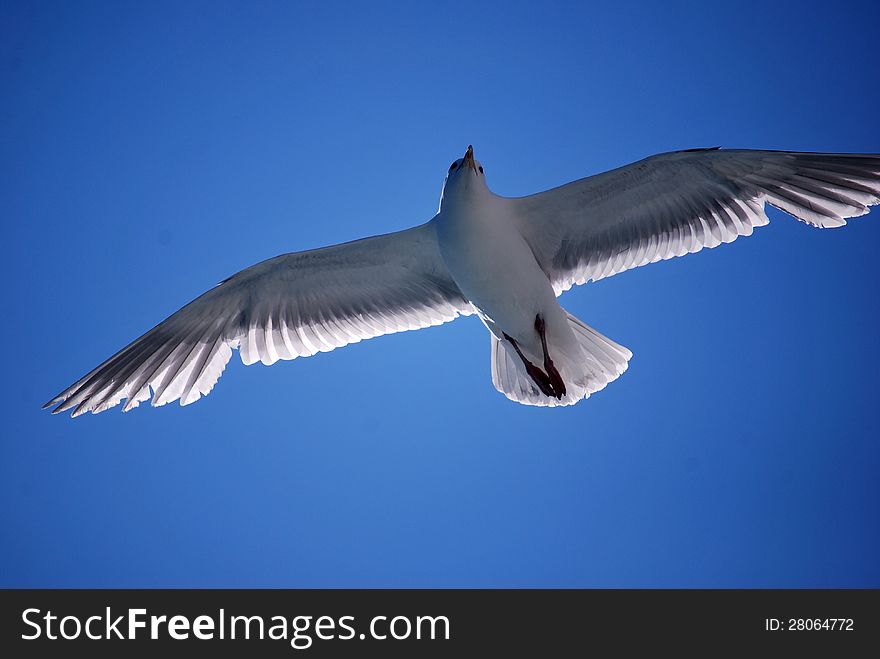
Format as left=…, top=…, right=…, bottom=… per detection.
left=510, top=149, right=880, bottom=295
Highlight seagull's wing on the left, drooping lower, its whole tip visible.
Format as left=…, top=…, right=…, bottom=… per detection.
left=44, top=221, right=472, bottom=416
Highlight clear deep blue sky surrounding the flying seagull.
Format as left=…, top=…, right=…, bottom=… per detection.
left=0, top=0, right=880, bottom=587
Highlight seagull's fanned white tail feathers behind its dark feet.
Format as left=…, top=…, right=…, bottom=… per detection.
left=491, top=312, right=632, bottom=407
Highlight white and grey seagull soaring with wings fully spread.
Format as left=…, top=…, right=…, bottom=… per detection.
left=43, top=146, right=880, bottom=417
